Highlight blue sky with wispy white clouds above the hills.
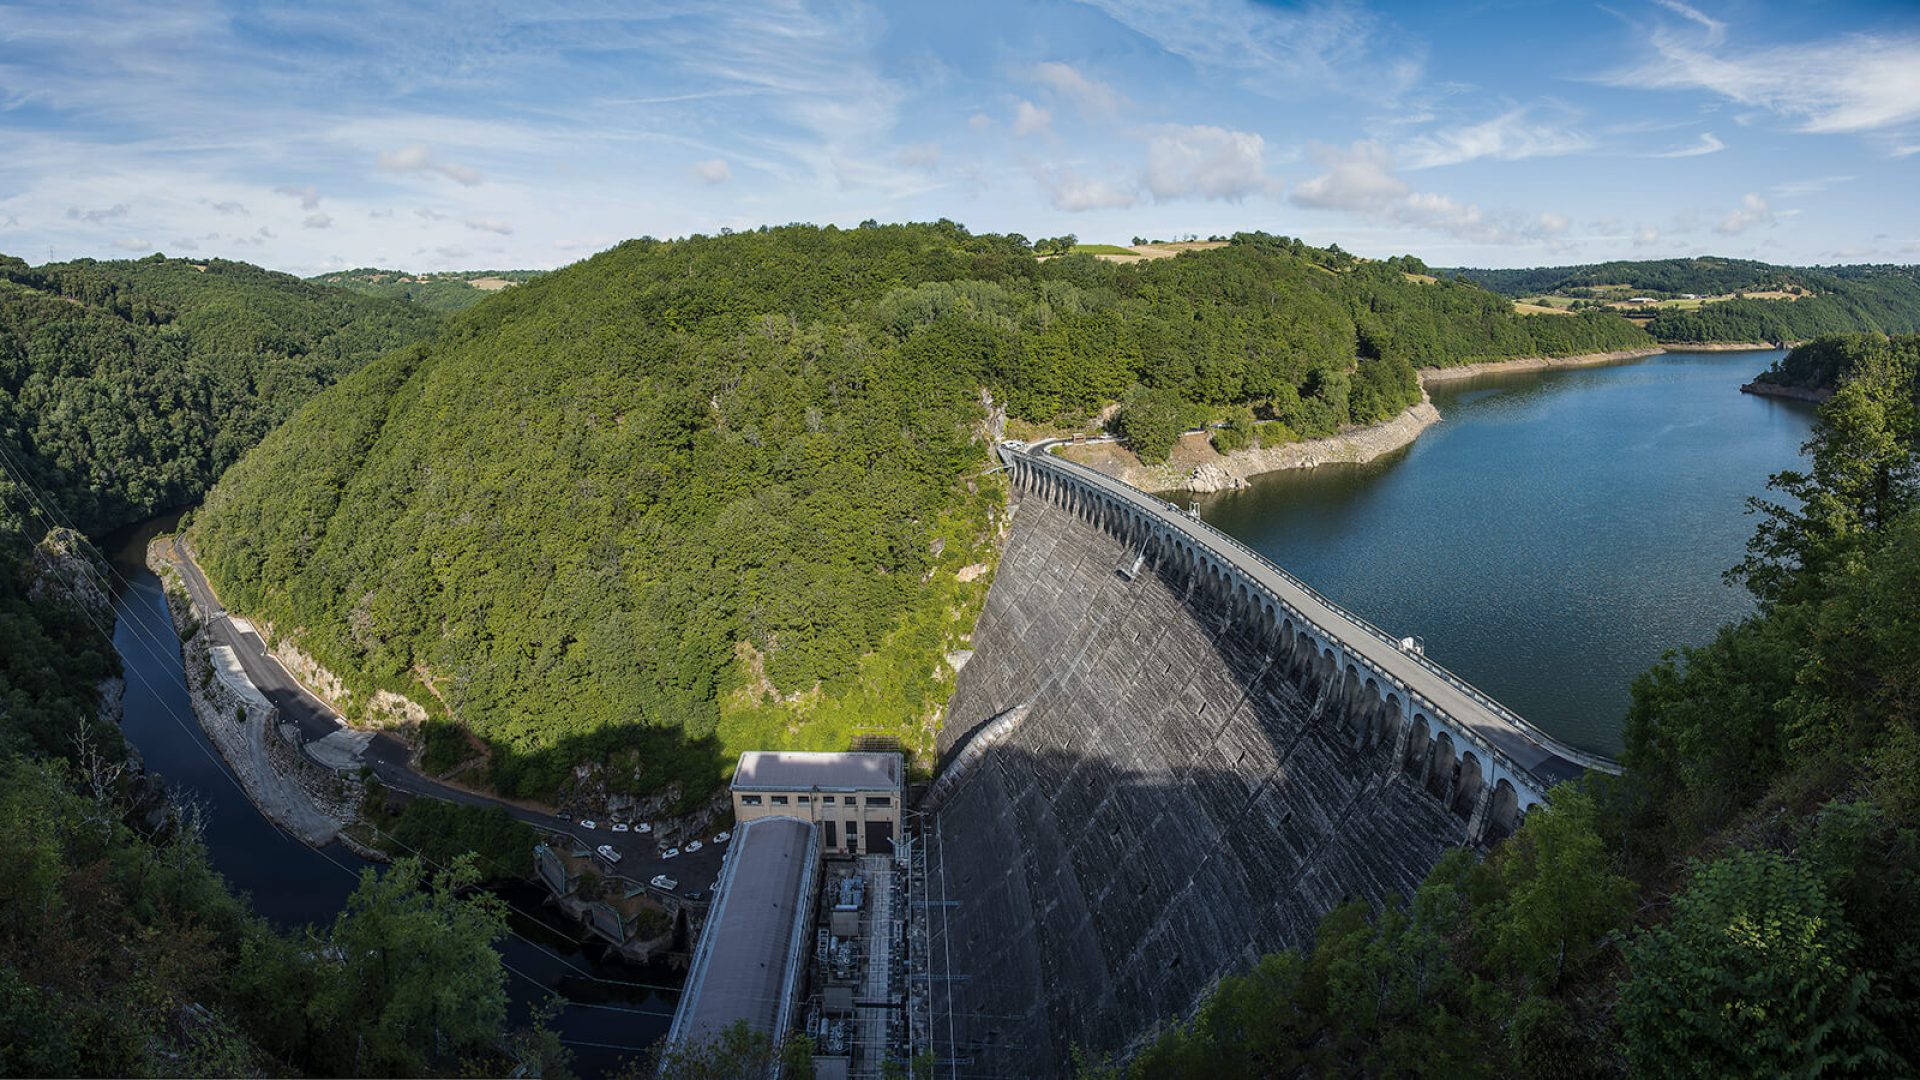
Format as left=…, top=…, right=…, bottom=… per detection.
left=0, top=0, right=1920, bottom=273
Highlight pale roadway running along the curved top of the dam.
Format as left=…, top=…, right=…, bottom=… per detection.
left=1000, top=432, right=1620, bottom=786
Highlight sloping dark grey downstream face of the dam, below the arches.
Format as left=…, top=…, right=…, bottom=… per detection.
left=924, top=496, right=1467, bottom=1076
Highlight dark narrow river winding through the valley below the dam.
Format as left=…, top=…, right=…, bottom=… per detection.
left=104, top=515, right=680, bottom=1076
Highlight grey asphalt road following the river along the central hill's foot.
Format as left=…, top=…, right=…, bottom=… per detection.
left=171, top=538, right=726, bottom=896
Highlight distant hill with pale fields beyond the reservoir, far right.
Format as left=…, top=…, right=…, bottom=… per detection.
left=1436, top=258, right=1920, bottom=344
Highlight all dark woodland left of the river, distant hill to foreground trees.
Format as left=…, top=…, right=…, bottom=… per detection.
left=0, top=259, right=540, bottom=1076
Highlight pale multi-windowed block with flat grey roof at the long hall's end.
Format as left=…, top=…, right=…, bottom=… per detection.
left=733, top=749, right=906, bottom=855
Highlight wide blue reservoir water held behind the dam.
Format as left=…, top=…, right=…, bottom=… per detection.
left=1175, top=352, right=1812, bottom=753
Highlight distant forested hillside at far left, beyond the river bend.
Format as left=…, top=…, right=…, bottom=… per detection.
left=0, top=256, right=438, bottom=534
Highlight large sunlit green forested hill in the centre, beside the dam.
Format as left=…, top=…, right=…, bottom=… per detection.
left=194, top=223, right=1645, bottom=798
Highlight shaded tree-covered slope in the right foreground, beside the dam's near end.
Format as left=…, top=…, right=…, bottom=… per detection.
left=1085, top=338, right=1920, bottom=1078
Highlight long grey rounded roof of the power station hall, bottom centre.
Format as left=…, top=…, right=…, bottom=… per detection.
left=666, top=817, right=820, bottom=1043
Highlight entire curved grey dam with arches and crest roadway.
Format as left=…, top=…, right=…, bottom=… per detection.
left=914, top=444, right=1617, bottom=1076
